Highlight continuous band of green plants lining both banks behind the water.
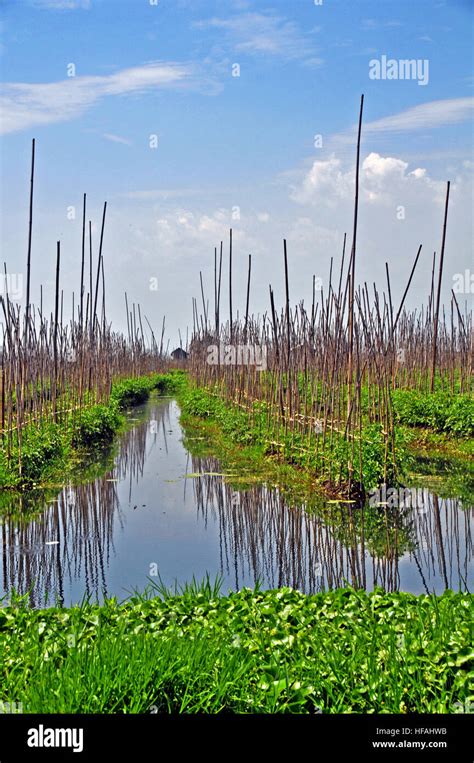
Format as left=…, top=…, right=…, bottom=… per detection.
left=0, top=370, right=468, bottom=502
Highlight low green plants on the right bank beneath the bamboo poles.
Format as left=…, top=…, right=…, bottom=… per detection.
left=179, top=386, right=474, bottom=505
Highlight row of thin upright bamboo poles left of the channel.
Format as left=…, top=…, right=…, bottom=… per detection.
left=0, top=140, right=168, bottom=473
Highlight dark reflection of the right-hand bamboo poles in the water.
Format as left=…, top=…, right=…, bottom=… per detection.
left=193, top=458, right=473, bottom=592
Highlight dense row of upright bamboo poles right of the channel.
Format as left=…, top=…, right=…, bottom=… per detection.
left=189, top=96, right=473, bottom=491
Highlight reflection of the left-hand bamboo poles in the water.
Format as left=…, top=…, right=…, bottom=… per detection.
left=0, top=396, right=174, bottom=606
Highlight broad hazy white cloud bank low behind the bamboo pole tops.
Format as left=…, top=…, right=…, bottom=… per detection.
left=4, top=164, right=474, bottom=346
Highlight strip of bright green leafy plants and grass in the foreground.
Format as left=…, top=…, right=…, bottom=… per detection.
left=0, top=581, right=474, bottom=713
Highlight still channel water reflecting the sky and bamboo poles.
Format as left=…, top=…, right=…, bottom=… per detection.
left=0, top=400, right=474, bottom=605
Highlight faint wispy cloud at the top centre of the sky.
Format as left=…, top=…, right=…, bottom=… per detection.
left=194, top=13, right=323, bottom=66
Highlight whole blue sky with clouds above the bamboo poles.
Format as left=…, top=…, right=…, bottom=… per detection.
left=0, top=0, right=474, bottom=343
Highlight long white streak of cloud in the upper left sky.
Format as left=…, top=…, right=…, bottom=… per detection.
left=0, top=63, right=193, bottom=133
